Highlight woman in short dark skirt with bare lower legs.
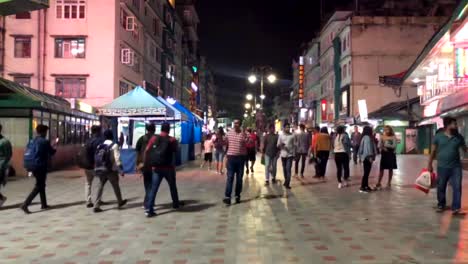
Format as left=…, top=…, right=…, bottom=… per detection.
left=375, top=126, right=397, bottom=191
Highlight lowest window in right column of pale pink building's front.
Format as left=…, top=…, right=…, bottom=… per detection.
left=55, top=77, right=86, bottom=98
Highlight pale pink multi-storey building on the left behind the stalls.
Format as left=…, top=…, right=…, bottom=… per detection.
left=3, top=0, right=168, bottom=106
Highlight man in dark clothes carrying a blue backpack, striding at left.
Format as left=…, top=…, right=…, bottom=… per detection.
left=21, top=125, right=57, bottom=214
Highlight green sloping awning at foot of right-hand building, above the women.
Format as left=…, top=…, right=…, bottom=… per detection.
left=369, top=97, right=419, bottom=121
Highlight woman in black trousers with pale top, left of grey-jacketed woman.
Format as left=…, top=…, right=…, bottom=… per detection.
left=333, top=126, right=351, bottom=189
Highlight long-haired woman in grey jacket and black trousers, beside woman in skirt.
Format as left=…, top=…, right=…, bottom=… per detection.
left=359, top=126, right=377, bottom=193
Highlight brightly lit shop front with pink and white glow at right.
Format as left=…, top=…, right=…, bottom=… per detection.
left=403, top=0, right=468, bottom=157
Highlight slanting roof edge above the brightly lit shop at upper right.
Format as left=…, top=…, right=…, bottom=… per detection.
left=402, top=0, right=468, bottom=82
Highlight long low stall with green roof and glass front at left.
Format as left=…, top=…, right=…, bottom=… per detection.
left=0, top=78, right=99, bottom=176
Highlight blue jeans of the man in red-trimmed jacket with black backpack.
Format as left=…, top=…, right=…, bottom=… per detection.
left=145, top=169, right=179, bottom=213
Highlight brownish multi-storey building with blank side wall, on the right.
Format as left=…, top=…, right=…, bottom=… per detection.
left=305, top=12, right=446, bottom=123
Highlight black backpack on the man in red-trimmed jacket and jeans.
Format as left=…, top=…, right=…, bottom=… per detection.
left=145, top=136, right=172, bottom=167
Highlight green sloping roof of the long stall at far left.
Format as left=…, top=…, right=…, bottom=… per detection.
left=0, top=78, right=72, bottom=113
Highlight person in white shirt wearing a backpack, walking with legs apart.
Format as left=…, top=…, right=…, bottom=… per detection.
left=94, top=130, right=127, bottom=213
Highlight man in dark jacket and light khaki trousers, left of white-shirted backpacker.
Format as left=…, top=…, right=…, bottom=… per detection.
left=85, top=126, right=104, bottom=208
